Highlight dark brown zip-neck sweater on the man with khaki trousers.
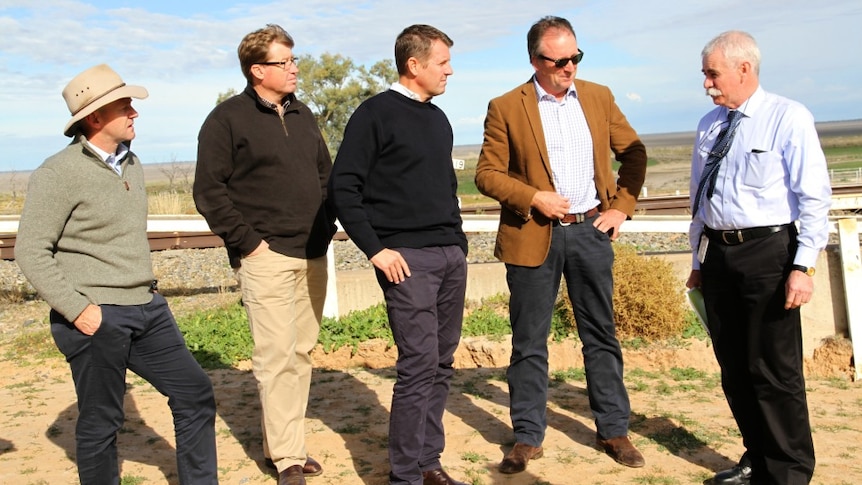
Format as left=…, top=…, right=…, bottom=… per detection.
left=194, top=86, right=335, bottom=268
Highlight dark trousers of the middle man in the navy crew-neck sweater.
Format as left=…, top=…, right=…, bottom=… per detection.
left=377, top=246, right=467, bottom=485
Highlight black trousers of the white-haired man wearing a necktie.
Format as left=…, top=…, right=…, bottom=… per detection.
left=701, top=227, right=814, bottom=485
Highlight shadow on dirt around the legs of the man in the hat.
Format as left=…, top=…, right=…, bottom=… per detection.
left=45, top=384, right=179, bottom=485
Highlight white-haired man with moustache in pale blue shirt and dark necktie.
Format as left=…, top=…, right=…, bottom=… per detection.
left=686, top=31, right=831, bottom=485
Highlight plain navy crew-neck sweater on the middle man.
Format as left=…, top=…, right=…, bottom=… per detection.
left=329, top=90, right=467, bottom=258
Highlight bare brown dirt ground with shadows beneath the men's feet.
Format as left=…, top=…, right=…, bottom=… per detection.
left=0, top=322, right=862, bottom=485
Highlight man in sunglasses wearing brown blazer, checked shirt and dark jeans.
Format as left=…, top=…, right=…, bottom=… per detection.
left=476, top=17, right=647, bottom=473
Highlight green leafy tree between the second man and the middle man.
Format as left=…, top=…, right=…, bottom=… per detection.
left=297, top=53, right=398, bottom=155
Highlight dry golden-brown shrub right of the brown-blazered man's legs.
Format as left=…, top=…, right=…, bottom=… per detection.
left=613, top=244, right=686, bottom=341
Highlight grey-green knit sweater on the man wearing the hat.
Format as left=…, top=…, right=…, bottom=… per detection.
left=15, top=137, right=153, bottom=321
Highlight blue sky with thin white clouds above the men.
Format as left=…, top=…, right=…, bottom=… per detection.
left=0, top=0, right=862, bottom=171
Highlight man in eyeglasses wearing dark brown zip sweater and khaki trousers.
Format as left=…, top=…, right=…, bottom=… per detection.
left=194, top=25, right=335, bottom=485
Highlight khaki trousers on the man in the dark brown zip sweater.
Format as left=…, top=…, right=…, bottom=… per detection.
left=236, top=250, right=327, bottom=472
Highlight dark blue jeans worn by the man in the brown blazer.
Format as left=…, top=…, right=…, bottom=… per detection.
left=506, top=217, right=631, bottom=446
